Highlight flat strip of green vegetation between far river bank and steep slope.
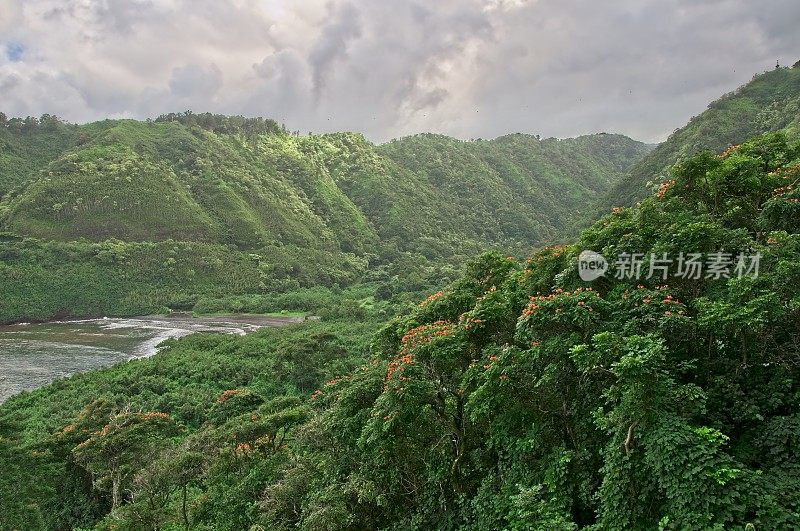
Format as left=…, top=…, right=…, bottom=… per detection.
left=0, top=237, right=376, bottom=323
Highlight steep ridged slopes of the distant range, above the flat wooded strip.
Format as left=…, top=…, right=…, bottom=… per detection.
left=2, top=119, right=647, bottom=257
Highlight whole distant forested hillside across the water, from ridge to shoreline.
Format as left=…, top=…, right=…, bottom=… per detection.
left=0, top=113, right=649, bottom=322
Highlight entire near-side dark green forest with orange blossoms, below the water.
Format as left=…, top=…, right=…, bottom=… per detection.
left=0, top=134, right=800, bottom=530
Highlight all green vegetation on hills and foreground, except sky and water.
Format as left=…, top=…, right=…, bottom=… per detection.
left=0, top=68, right=800, bottom=530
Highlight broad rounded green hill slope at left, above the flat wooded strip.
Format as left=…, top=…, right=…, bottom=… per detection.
left=0, top=120, right=356, bottom=249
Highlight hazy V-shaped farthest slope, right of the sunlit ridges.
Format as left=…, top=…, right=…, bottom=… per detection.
left=379, top=134, right=648, bottom=247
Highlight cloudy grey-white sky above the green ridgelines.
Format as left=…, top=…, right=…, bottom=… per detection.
left=0, top=0, right=800, bottom=141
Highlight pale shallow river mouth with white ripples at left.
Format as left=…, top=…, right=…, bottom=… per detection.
left=0, top=314, right=303, bottom=403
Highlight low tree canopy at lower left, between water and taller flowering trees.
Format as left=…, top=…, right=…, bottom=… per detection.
left=0, top=316, right=376, bottom=529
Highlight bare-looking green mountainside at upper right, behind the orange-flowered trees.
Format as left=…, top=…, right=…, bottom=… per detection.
left=600, top=64, right=800, bottom=212
